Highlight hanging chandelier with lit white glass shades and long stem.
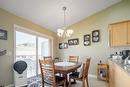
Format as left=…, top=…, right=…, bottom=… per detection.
left=57, top=7, right=74, bottom=38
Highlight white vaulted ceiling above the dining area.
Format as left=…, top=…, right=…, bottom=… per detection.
left=0, top=0, right=121, bottom=31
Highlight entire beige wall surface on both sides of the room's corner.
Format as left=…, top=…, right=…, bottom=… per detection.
left=0, top=0, right=130, bottom=85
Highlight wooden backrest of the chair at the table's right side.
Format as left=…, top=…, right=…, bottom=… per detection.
left=83, top=58, right=91, bottom=78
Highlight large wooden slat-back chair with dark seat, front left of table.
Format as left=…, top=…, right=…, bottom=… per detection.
left=39, top=58, right=66, bottom=87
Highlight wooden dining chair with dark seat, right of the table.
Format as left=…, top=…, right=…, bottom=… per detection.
left=69, top=58, right=91, bottom=87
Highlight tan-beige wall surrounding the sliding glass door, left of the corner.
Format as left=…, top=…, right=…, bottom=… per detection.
left=0, top=9, right=57, bottom=85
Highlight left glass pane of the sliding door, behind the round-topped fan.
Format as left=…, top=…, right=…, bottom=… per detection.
left=16, top=31, right=36, bottom=77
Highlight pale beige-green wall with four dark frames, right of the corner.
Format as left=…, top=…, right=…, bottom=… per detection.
left=58, top=0, right=130, bottom=75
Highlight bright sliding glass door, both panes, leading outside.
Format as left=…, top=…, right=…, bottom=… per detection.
left=15, top=30, right=51, bottom=78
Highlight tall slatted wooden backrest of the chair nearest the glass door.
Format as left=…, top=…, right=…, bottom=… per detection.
left=39, top=58, right=56, bottom=87
